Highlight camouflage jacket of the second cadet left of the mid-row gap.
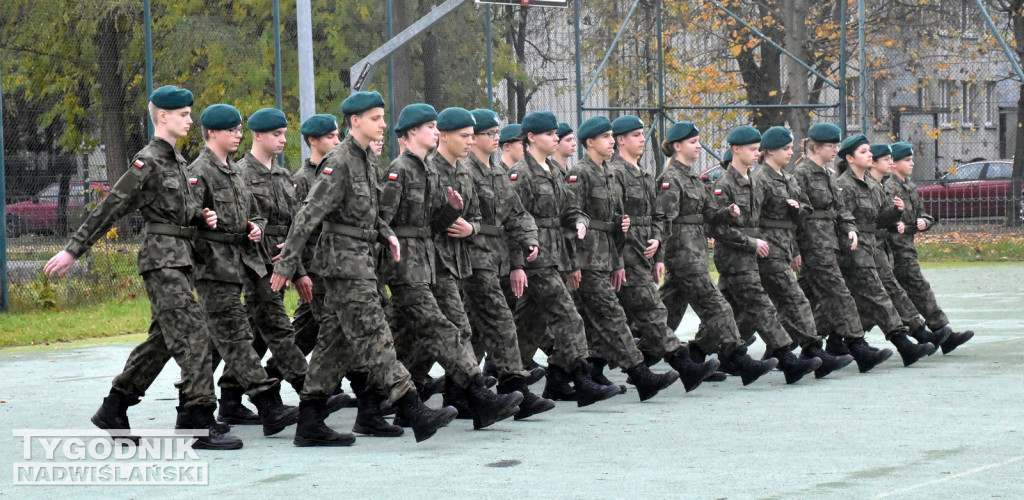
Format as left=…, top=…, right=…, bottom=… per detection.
left=566, top=156, right=626, bottom=272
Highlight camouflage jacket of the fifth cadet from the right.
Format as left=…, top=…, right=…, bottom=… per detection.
left=751, top=165, right=814, bottom=273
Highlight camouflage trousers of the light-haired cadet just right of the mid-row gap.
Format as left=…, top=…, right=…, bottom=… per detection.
left=660, top=269, right=744, bottom=356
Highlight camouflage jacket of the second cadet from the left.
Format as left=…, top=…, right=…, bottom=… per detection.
left=188, top=147, right=266, bottom=284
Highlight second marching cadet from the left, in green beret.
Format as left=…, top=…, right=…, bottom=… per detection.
left=188, top=105, right=305, bottom=435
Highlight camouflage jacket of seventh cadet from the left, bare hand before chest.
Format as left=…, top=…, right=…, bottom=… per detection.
left=427, top=151, right=480, bottom=280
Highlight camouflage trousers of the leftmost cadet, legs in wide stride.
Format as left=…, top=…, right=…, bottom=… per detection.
left=113, top=267, right=217, bottom=408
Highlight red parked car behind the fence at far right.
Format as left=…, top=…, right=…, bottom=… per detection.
left=918, top=160, right=1014, bottom=219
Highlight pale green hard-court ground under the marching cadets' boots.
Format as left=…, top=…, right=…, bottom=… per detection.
left=0, top=263, right=1024, bottom=499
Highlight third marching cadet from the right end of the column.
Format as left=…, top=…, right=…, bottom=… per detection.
left=836, top=134, right=938, bottom=366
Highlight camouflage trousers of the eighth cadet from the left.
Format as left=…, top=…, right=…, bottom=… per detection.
left=462, top=269, right=529, bottom=381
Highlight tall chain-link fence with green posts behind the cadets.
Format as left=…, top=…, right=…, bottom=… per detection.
left=8, top=0, right=1021, bottom=310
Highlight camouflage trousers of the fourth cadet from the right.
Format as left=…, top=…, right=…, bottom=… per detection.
left=798, top=248, right=864, bottom=340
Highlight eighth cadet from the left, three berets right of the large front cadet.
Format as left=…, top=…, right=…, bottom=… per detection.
left=460, top=110, right=555, bottom=420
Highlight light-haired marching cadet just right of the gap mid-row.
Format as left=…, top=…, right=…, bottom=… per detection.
left=652, top=122, right=778, bottom=385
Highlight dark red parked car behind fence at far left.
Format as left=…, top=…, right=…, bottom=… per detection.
left=7, top=182, right=142, bottom=238
